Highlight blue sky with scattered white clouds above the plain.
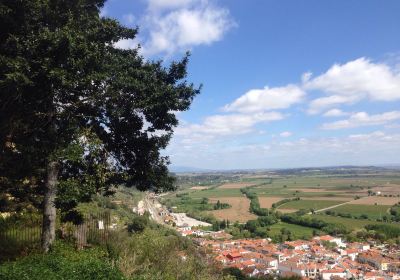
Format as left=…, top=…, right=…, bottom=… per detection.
left=102, top=0, right=400, bottom=169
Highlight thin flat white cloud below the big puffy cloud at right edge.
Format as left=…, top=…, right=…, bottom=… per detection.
left=322, top=111, right=400, bottom=129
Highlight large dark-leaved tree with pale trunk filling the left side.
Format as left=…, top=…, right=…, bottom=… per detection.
left=0, top=0, right=199, bottom=251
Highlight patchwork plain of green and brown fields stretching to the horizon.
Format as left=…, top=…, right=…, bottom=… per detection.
left=167, top=167, right=400, bottom=227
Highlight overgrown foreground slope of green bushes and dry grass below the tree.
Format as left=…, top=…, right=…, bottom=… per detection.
left=0, top=197, right=231, bottom=280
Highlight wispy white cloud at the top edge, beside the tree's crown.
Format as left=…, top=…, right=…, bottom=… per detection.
left=143, top=0, right=235, bottom=56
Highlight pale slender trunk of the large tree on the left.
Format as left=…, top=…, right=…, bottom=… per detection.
left=42, top=161, right=60, bottom=252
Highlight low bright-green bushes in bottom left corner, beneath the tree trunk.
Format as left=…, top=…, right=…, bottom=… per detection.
left=0, top=243, right=125, bottom=280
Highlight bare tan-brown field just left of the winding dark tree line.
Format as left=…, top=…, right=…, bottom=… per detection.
left=209, top=197, right=257, bottom=222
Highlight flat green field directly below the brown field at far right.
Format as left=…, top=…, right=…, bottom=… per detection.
left=332, top=204, right=390, bottom=219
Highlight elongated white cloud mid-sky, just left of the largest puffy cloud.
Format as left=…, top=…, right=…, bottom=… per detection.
left=224, top=85, right=305, bottom=113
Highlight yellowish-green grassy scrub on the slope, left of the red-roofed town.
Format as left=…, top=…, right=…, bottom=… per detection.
left=108, top=228, right=222, bottom=280
